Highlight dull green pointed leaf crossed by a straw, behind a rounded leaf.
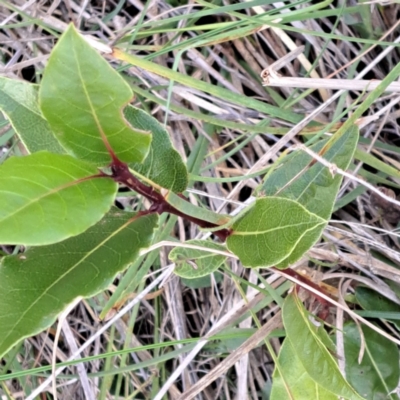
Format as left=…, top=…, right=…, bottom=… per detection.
left=260, top=126, right=358, bottom=219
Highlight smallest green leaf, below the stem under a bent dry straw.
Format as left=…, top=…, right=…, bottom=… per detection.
left=168, top=239, right=226, bottom=279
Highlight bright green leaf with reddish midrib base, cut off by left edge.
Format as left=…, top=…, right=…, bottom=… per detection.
left=0, top=152, right=117, bottom=246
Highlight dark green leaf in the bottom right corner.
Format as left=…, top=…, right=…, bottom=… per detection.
left=344, top=323, right=399, bottom=400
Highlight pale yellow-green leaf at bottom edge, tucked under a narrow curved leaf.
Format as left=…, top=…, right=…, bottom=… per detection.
left=270, top=339, right=338, bottom=400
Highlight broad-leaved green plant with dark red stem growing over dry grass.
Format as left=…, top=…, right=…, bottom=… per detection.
left=0, top=26, right=368, bottom=398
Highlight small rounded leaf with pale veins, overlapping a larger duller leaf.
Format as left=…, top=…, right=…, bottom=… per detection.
left=227, top=197, right=326, bottom=267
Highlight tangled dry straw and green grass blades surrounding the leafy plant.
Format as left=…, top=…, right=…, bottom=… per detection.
left=0, top=0, right=400, bottom=400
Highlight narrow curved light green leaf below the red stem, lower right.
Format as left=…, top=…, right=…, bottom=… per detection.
left=282, top=293, right=361, bottom=399
